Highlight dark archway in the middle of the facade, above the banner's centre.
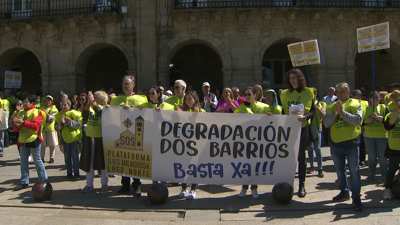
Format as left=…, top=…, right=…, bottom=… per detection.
left=168, top=44, right=223, bottom=93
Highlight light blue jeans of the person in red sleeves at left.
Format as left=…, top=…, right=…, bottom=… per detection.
left=20, top=144, right=47, bottom=184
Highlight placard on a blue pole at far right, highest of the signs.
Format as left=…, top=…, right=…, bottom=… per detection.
left=357, top=22, right=390, bottom=53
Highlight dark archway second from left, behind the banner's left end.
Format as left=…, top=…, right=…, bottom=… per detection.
left=85, top=47, right=128, bottom=95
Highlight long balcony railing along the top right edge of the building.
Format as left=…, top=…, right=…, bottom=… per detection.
left=175, top=0, right=400, bottom=9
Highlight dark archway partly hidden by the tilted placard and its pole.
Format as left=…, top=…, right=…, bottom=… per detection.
left=262, top=38, right=309, bottom=90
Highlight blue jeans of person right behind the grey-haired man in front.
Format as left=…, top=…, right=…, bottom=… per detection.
left=364, top=136, right=389, bottom=183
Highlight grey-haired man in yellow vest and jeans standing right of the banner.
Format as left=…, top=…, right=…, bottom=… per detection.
left=323, top=82, right=364, bottom=211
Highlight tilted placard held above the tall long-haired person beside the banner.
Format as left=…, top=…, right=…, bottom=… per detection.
left=288, top=39, right=321, bottom=67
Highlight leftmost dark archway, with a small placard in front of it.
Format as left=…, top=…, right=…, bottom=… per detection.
left=0, top=48, right=42, bottom=94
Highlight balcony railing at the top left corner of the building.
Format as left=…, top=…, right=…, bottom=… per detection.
left=0, top=0, right=120, bottom=19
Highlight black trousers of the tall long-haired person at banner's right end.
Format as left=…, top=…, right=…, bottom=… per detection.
left=298, top=125, right=310, bottom=184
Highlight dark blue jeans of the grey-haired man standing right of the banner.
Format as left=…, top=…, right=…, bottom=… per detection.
left=331, top=145, right=361, bottom=198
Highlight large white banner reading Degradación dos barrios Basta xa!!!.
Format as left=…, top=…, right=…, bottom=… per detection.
left=101, top=107, right=301, bottom=184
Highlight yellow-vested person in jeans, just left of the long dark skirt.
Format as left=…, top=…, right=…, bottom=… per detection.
left=55, top=99, right=82, bottom=180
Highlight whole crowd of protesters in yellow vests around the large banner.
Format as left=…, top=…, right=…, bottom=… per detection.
left=4, top=68, right=400, bottom=213
